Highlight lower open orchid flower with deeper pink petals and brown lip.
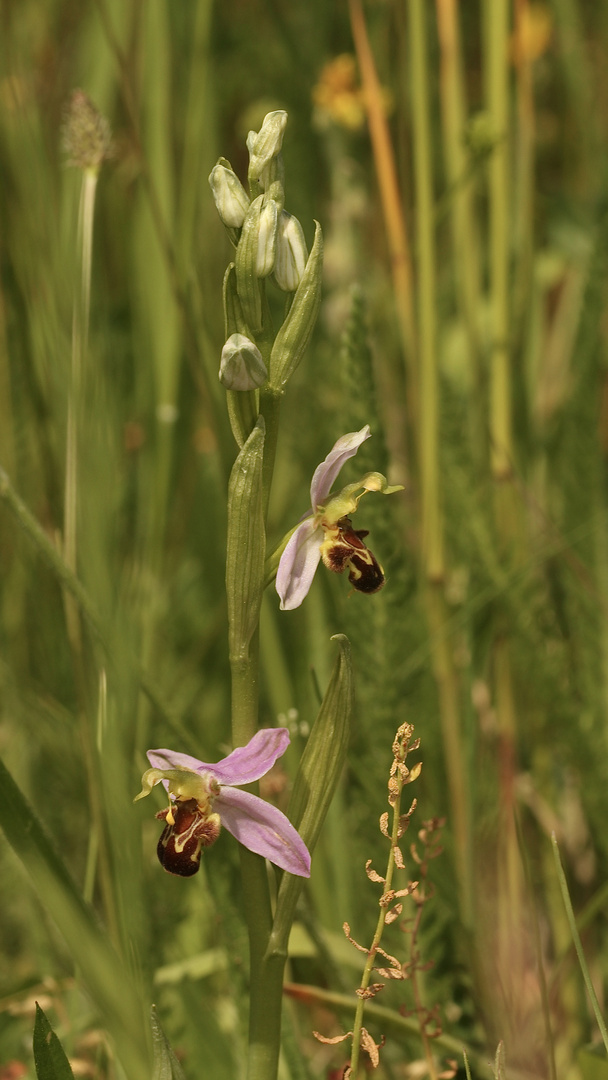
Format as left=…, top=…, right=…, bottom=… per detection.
left=134, top=728, right=310, bottom=877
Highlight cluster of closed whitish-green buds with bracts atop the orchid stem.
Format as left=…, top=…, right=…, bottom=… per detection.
left=210, top=109, right=323, bottom=401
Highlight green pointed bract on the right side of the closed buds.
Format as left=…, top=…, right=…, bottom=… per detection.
left=270, top=221, right=323, bottom=390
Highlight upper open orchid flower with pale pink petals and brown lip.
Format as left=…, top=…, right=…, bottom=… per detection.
left=276, top=424, right=403, bottom=611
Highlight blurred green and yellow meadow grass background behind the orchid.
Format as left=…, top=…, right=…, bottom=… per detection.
left=0, top=0, right=608, bottom=1080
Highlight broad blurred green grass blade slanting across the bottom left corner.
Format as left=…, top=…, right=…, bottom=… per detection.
left=0, top=761, right=150, bottom=1080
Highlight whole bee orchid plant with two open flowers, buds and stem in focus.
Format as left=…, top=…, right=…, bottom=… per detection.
left=136, top=110, right=398, bottom=1080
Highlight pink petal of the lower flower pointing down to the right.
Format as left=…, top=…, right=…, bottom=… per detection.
left=214, top=787, right=310, bottom=877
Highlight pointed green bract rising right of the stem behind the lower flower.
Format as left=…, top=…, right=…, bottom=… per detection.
left=268, top=634, right=354, bottom=954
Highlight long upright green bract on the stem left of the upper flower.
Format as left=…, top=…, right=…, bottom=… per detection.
left=226, top=416, right=266, bottom=662
